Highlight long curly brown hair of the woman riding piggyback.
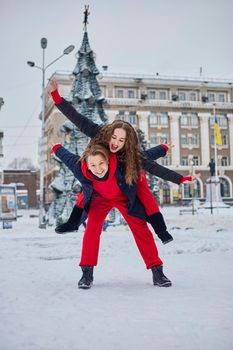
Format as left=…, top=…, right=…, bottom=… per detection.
left=87, top=120, right=143, bottom=185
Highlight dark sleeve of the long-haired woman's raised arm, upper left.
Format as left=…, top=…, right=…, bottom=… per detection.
left=56, top=98, right=102, bottom=138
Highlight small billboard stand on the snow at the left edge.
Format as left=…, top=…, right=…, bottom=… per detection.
left=0, top=184, right=17, bottom=221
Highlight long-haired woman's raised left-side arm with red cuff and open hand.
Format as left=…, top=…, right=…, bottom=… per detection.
left=49, top=80, right=102, bottom=138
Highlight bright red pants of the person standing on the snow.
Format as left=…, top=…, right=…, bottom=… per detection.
left=80, top=195, right=163, bottom=269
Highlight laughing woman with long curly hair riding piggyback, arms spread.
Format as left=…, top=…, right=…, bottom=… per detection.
left=51, top=81, right=193, bottom=244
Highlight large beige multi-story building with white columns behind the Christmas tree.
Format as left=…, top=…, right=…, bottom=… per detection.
left=45, top=71, right=233, bottom=203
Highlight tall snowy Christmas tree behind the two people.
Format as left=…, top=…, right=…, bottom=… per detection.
left=49, top=26, right=106, bottom=224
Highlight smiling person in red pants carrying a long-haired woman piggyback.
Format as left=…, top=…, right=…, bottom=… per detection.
left=52, top=144, right=172, bottom=289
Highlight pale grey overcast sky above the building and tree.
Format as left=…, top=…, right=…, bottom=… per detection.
left=0, top=0, right=233, bottom=167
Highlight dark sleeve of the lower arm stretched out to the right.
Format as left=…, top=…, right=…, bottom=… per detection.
left=143, top=159, right=183, bottom=185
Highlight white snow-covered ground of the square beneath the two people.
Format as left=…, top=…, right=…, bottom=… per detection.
left=0, top=207, right=233, bottom=350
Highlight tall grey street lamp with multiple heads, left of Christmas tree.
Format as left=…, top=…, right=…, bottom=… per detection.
left=27, top=38, right=74, bottom=228
